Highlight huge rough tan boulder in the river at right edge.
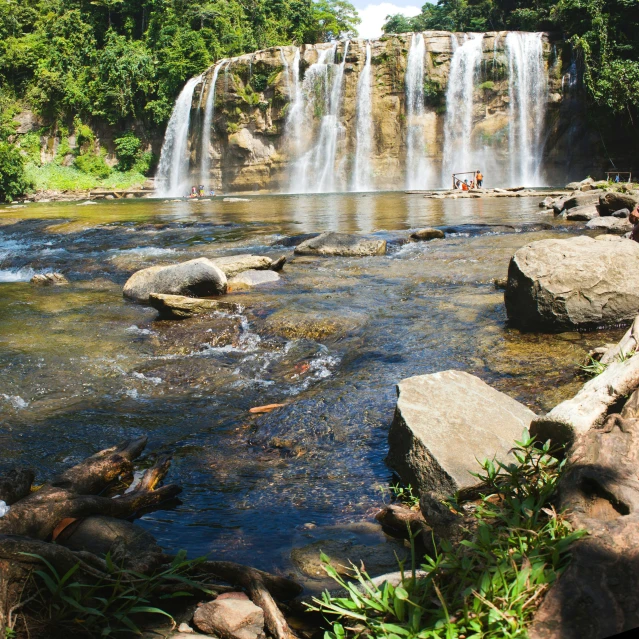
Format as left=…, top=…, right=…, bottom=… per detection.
left=504, top=238, right=639, bottom=330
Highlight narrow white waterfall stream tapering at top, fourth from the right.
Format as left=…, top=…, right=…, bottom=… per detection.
left=353, top=41, right=373, bottom=191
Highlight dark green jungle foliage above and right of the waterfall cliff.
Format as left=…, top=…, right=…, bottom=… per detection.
left=384, top=0, right=639, bottom=121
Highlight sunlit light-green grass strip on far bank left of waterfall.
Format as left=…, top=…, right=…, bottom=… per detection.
left=26, top=162, right=146, bottom=191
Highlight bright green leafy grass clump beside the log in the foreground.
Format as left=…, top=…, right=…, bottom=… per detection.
left=310, top=434, right=585, bottom=639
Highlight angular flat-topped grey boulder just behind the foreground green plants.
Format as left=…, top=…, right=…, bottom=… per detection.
left=388, top=370, right=535, bottom=496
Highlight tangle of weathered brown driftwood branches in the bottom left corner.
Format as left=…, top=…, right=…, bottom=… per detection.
left=0, top=437, right=302, bottom=639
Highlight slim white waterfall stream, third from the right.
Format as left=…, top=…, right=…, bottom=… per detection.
left=406, top=33, right=430, bottom=189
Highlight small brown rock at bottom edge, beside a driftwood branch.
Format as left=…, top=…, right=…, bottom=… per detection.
left=193, top=598, right=264, bottom=639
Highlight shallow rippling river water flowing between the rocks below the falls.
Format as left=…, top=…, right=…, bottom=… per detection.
left=0, top=193, right=622, bottom=584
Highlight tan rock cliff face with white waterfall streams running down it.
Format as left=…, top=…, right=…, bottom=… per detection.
left=158, top=31, right=592, bottom=195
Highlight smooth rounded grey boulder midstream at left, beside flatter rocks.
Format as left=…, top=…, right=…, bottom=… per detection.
left=123, top=257, right=227, bottom=303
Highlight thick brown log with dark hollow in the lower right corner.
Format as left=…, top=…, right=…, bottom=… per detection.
left=529, top=356, right=639, bottom=639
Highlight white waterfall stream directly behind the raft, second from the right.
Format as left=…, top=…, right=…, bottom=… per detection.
left=442, top=33, right=484, bottom=188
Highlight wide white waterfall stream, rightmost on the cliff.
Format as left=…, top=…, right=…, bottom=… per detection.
left=506, top=32, right=548, bottom=186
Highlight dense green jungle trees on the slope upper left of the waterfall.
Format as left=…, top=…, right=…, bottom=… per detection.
left=0, top=0, right=359, bottom=125
